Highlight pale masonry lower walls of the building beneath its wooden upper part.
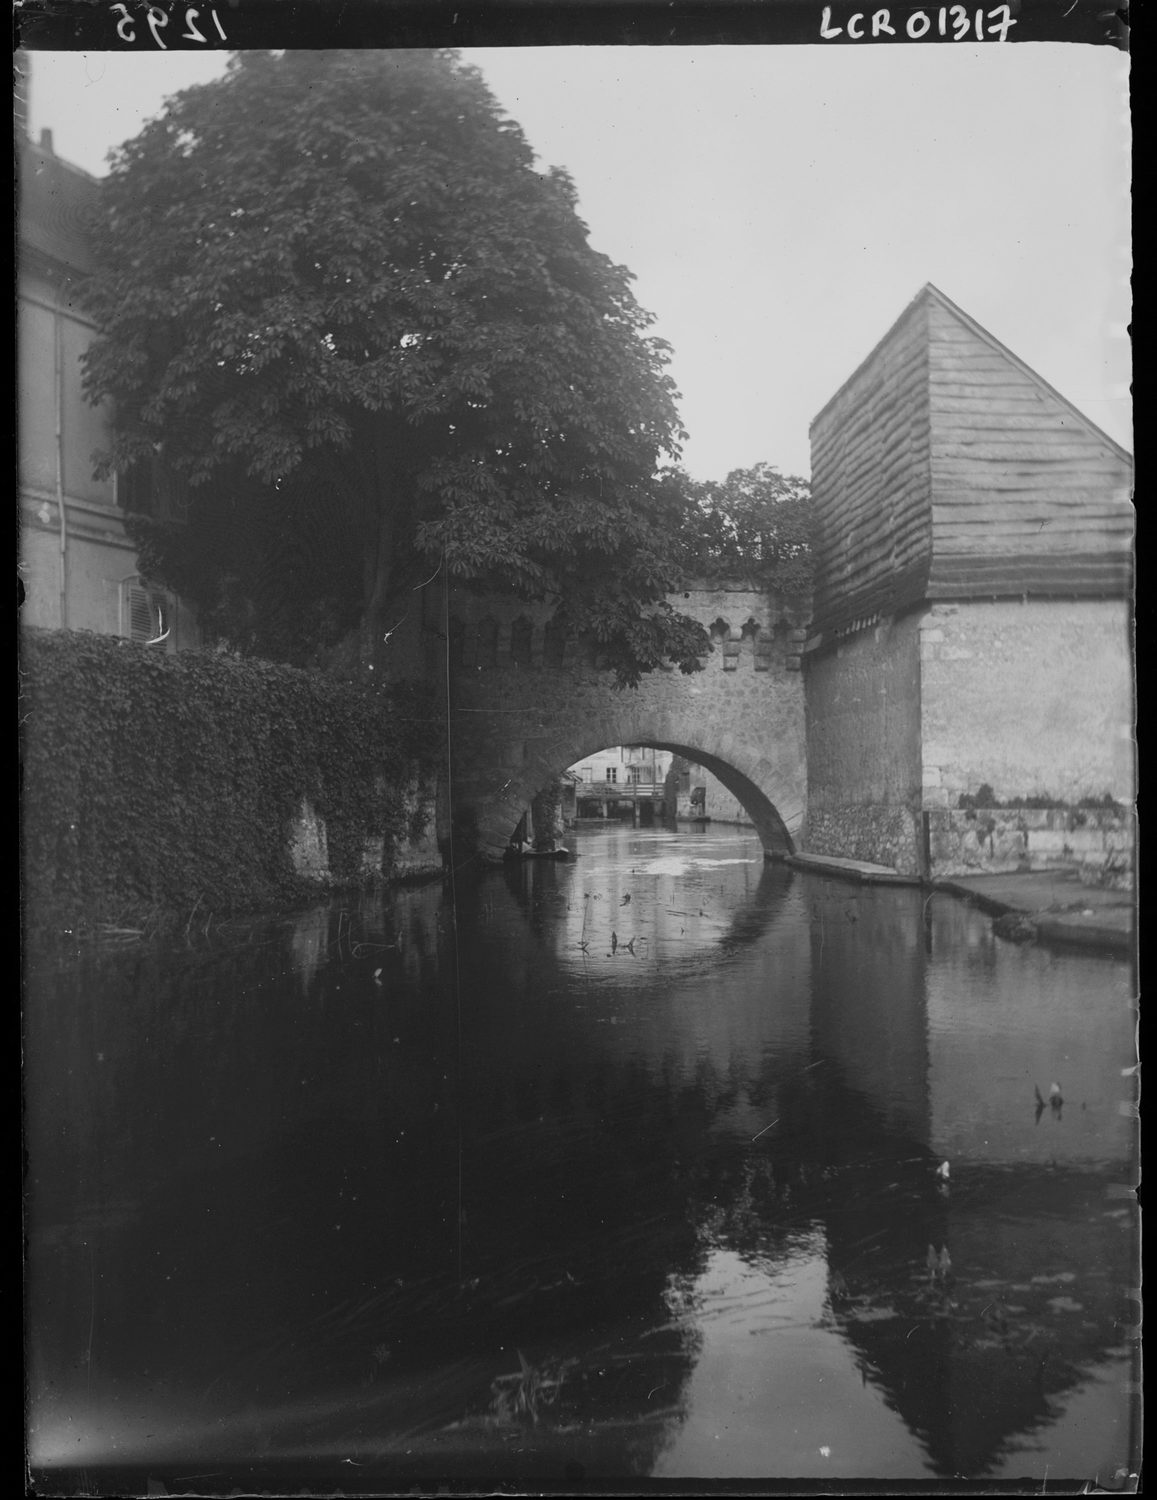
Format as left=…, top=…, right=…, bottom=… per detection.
left=804, top=600, right=1134, bottom=885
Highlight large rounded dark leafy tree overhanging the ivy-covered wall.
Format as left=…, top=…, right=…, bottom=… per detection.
left=84, top=51, right=705, bottom=681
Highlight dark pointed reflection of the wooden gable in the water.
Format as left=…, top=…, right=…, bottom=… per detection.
left=828, top=1167, right=1133, bottom=1478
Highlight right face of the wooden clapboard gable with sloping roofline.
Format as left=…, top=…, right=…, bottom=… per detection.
left=923, top=287, right=1133, bottom=599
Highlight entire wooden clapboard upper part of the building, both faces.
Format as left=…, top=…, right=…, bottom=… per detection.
left=812, top=285, right=1133, bottom=635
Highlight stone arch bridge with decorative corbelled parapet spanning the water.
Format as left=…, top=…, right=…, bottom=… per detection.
left=446, top=588, right=807, bottom=858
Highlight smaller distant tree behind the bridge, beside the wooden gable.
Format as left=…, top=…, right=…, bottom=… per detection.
left=663, top=464, right=815, bottom=600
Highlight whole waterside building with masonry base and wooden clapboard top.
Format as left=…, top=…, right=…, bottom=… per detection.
left=803, top=285, right=1134, bottom=875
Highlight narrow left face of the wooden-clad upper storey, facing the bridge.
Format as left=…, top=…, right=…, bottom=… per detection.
left=812, top=286, right=932, bottom=632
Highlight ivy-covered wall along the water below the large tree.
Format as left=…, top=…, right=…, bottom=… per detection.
left=20, top=630, right=444, bottom=927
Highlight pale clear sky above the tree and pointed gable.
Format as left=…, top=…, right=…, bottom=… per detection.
left=20, top=44, right=1131, bottom=479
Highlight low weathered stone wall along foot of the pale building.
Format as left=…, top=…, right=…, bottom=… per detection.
left=926, top=807, right=1134, bottom=890
